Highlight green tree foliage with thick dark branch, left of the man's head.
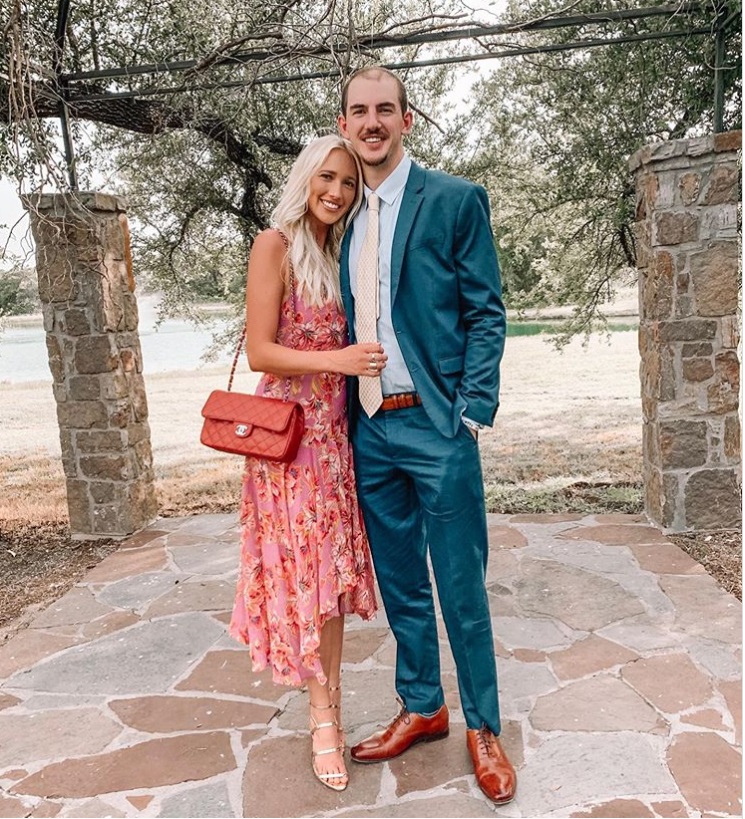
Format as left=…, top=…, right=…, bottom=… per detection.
left=0, top=0, right=470, bottom=320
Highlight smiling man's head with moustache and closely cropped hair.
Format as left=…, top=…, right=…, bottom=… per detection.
left=338, top=72, right=413, bottom=188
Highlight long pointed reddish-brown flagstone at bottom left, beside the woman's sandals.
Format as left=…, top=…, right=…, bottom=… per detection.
left=11, top=732, right=236, bottom=799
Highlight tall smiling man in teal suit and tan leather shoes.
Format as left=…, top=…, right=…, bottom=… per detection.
left=339, top=67, right=516, bottom=804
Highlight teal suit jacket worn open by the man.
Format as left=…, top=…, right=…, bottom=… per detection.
left=341, top=163, right=507, bottom=438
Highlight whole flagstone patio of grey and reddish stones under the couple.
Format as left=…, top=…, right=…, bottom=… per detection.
left=0, top=515, right=742, bottom=817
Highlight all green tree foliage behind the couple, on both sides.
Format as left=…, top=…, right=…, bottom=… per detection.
left=0, top=0, right=741, bottom=332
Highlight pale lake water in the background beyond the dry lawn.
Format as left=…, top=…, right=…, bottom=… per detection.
left=0, top=299, right=637, bottom=384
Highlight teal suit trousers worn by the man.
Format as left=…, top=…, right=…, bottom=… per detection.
left=353, top=407, right=500, bottom=734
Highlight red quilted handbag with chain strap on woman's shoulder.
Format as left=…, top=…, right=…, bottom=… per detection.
left=199, top=234, right=305, bottom=463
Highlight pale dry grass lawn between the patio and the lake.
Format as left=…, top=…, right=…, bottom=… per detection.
left=0, top=332, right=641, bottom=522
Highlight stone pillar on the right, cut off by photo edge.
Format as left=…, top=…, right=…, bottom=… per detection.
left=629, top=131, right=742, bottom=532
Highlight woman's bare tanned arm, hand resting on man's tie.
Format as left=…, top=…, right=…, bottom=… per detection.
left=246, top=230, right=387, bottom=376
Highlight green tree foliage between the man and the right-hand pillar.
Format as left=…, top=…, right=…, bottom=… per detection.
left=464, top=0, right=742, bottom=340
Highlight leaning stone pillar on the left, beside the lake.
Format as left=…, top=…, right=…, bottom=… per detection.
left=24, top=193, right=157, bottom=539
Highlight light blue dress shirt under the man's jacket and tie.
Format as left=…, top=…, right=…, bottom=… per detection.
left=349, top=155, right=415, bottom=395
